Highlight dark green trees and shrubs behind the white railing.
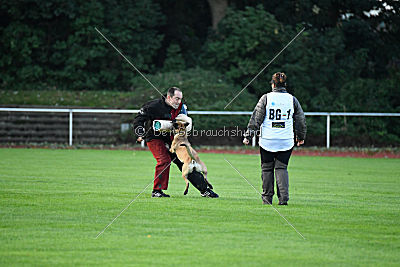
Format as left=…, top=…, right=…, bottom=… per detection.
left=0, top=0, right=400, bottom=145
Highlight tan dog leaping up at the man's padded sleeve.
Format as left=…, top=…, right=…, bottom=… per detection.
left=169, top=121, right=213, bottom=195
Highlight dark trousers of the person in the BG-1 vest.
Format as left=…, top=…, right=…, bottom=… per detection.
left=260, top=147, right=293, bottom=204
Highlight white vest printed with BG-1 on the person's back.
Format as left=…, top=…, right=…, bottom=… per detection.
left=260, top=92, right=294, bottom=151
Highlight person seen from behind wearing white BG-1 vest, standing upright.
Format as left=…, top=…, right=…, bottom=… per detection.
left=243, top=72, right=307, bottom=205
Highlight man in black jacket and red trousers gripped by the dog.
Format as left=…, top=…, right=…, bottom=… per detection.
left=133, top=87, right=216, bottom=197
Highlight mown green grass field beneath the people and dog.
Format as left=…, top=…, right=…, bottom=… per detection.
left=0, top=149, right=400, bottom=266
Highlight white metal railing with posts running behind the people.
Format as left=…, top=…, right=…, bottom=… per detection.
left=0, top=108, right=400, bottom=148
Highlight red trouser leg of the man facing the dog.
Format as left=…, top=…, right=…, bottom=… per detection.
left=147, top=139, right=171, bottom=190
